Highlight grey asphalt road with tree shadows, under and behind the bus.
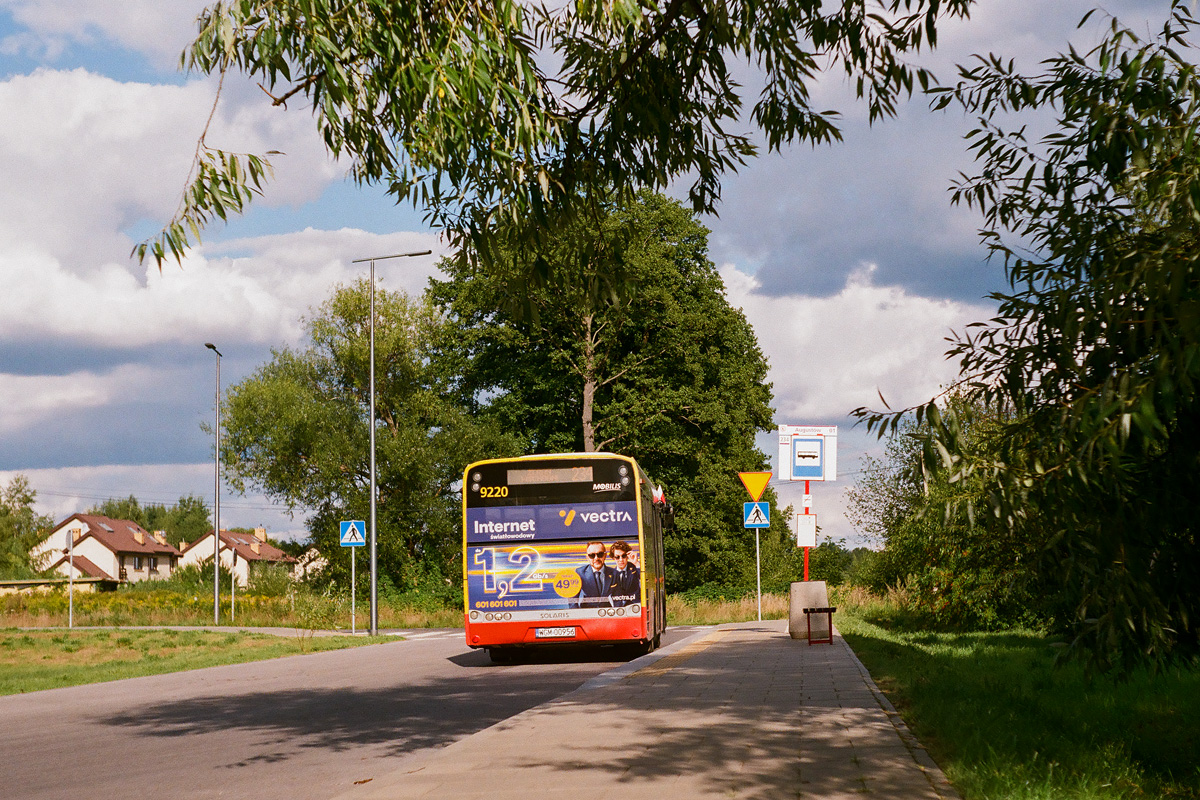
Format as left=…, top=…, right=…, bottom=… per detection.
left=0, top=630, right=688, bottom=800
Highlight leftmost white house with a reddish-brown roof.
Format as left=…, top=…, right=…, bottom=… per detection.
left=32, top=513, right=182, bottom=583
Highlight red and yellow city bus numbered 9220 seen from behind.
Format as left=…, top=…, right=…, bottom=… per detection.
left=462, top=452, right=670, bottom=663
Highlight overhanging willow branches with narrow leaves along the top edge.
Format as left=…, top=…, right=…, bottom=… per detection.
left=136, top=0, right=971, bottom=273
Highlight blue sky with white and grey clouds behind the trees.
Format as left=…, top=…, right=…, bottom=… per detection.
left=0, top=0, right=1168, bottom=541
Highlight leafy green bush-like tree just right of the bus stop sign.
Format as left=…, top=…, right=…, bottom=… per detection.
left=846, top=393, right=1061, bottom=627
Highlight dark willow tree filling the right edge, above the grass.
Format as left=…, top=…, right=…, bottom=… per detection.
left=863, top=1, right=1200, bottom=669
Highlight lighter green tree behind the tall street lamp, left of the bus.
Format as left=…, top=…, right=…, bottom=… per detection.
left=221, top=281, right=517, bottom=585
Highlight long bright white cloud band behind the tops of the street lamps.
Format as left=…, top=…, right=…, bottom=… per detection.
left=0, top=229, right=445, bottom=349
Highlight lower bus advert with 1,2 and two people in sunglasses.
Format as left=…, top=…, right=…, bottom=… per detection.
left=467, top=542, right=641, bottom=620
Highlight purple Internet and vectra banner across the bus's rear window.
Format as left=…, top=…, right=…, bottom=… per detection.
left=466, top=500, right=637, bottom=545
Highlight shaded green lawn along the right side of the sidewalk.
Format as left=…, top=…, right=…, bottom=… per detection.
left=836, top=603, right=1200, bottom=800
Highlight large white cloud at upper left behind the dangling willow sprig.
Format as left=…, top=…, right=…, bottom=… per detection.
left=0, top=68, right=343, bottom=271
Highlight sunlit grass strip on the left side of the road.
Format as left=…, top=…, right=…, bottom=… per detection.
left=0, top=628, right=395, bottom=694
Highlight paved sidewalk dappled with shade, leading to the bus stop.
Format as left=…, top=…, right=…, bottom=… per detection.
left=341, top=620, right=958, bottom=800
